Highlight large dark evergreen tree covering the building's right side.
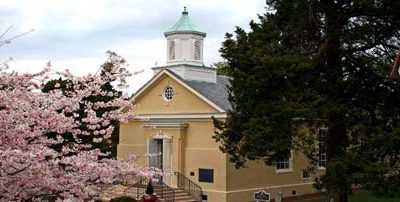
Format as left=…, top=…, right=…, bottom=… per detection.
left=214, top=0, right=400, bottom=201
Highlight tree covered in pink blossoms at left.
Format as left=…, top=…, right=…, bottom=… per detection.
left=0, top=54, right=151, bottom=201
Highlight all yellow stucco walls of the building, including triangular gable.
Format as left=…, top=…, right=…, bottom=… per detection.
left=118, top=75, right=324, bottom=202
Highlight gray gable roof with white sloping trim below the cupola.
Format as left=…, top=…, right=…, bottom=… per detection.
left=131, top=69, right=232, bottom=112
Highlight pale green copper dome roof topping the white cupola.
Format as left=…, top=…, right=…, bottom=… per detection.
left=164, top=7, right=206, bottom=36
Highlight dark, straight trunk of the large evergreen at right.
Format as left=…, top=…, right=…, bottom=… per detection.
left=321, top=0, right=349, bottom=202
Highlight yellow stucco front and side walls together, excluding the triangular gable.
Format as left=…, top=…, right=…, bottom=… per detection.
left=118, top=119, right=322, bottom=202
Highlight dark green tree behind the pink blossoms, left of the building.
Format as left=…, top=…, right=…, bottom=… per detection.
left=42, top=51, right=126, bottom=157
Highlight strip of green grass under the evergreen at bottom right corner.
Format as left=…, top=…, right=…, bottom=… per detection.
left=303, top=192, right=400, bottom=202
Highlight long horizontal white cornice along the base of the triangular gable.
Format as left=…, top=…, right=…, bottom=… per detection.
left=136, top=113, right=228, bottom=120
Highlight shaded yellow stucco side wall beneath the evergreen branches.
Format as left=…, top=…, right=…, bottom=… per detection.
left=226, top=152, right=323, bottom=202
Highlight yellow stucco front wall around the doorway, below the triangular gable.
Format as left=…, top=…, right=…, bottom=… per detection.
left=118, top=118, right=227, bottom=201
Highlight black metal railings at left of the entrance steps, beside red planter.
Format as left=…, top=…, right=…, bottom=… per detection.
left=124, top=179, right=175, bottom=202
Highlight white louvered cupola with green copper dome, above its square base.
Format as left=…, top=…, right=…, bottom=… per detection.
left=164, top=7, right=206, bottom=66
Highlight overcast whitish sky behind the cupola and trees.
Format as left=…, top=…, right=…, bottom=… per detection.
left=0, top=0, right=265, bottom=92
